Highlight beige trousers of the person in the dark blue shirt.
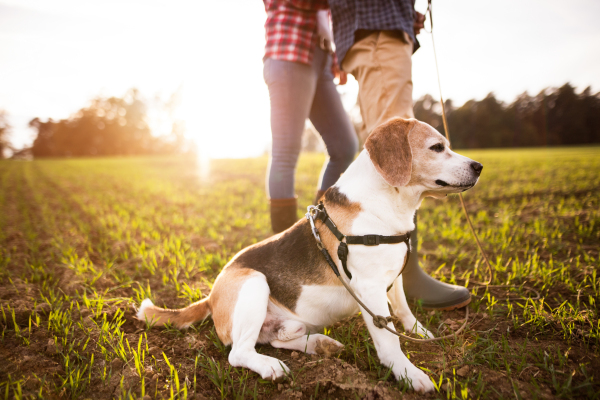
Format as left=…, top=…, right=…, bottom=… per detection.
left=342, top=31, right=414, bottom=142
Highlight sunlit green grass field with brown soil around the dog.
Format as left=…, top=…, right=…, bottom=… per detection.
left=0, top=147, right=600, bottom=399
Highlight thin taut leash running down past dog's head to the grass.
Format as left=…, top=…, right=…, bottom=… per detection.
left=425, top=0, right=541, bottom=300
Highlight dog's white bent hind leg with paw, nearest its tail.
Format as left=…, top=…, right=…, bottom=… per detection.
left=225, top=272, right=289, bottom=380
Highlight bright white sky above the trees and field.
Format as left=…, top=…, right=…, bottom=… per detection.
left=0, top=0, right=600, bottom=158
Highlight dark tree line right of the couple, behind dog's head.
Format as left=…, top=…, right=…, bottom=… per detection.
left=414, top=83, right=600, bottom=149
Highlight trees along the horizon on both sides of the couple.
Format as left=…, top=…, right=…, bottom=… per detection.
left=0, top=83, right=600, bottom=158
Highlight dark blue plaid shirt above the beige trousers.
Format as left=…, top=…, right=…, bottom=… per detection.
left=329, top=0, right=418, bottom=64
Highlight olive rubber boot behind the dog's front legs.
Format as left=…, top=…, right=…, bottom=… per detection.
left=402, top=213, right=471, bottom=310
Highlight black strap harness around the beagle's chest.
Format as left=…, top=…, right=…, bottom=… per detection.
left=306, top=202, right=412, bottom=280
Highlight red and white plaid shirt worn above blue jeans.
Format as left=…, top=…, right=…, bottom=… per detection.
left=263, top=0, right=329, bottom=64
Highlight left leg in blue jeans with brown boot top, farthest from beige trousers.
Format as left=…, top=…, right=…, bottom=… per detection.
left=264, top=54, right=318, bottom=233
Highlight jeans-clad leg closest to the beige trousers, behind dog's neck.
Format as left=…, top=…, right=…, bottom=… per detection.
left=309, top=51, right=358, bottom=201
